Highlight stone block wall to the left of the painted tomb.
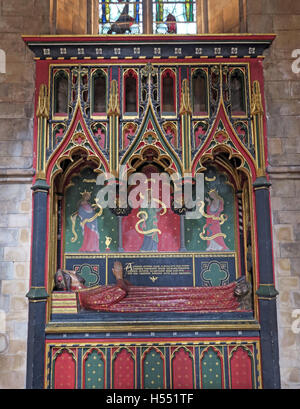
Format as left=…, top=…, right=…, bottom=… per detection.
left=0, top=0, right=88, bottom=389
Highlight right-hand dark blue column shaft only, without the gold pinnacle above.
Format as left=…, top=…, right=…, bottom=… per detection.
left=253, top=177, right=280, bottom=389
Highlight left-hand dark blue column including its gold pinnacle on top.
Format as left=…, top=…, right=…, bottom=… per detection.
left=26, top=84, right=49, bottom=389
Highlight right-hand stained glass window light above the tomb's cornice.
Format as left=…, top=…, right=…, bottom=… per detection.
left=153, top=0, right=197, bottom=34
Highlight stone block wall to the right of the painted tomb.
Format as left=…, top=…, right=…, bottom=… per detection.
left=247, top=0, right=300, bottom=389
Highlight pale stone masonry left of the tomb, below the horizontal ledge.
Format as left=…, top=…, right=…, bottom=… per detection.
left=0, top=184, right=32, bottom=389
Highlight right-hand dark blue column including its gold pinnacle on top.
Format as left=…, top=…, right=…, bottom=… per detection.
left=251, top=80, right=280, bottom=389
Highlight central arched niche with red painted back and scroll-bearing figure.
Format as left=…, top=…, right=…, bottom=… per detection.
left=122, top=146, right=180, bottom=252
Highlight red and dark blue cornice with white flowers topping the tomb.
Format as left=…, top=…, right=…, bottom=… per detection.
left=23, top=34, right=276, bottom=62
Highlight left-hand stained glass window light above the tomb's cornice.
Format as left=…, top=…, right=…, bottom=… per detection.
left=99, top=0, right=143, bottom=34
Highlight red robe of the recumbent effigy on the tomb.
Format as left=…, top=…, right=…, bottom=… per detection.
left=78, top=283, right=239, bottom=313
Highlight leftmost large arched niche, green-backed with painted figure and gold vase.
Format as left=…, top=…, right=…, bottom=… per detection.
left=48, top=148, right=118, bottom=292
